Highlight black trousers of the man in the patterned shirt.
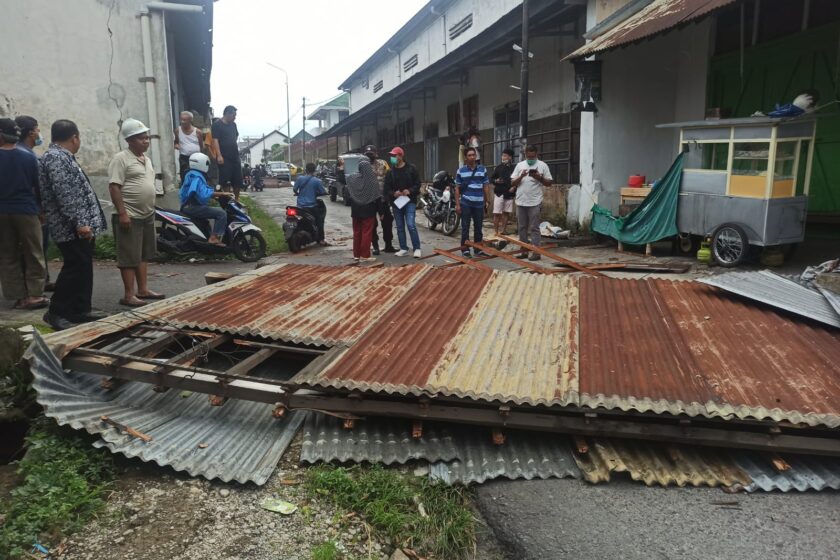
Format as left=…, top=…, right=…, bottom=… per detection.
left=50, top=239, right=94, bottom=322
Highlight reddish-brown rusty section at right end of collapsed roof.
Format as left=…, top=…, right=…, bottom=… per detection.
left=580, top=278, right=840, bottom=427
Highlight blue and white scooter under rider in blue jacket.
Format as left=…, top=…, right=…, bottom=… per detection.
left=155, top=197, right=266, bottom=262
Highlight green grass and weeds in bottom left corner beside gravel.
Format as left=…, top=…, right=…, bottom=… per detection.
left=0, top=417, right=114, bottom=558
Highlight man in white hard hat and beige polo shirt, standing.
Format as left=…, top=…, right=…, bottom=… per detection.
left=108, top=119, right=164, bottom=307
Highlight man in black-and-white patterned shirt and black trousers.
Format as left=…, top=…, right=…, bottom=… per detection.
left=40, top=119, right=107, bottom=330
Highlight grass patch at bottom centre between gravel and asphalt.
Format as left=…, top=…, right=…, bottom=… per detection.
left=306, top=465, right=475, bottom=559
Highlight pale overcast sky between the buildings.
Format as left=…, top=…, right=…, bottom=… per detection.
left=210, top=0, right=426, bottom=136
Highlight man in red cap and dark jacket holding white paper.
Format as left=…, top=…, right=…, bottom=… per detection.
left=384, top=147, right=422, bottom=259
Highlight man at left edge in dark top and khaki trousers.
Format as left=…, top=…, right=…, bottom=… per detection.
left=0, top=119, right=49, bottom=309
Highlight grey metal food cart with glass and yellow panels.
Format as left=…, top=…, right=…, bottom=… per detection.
left=657, top=116, right=816, bottom=266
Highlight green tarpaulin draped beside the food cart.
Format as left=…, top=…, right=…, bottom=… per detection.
left=592, top=154, right=683, bottom=245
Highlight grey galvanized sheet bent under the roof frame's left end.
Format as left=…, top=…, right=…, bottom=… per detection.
left=27, top=334, right=307, bottom=485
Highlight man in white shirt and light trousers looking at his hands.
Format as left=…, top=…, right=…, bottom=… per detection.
left=511, top=146, right=552, bottom=261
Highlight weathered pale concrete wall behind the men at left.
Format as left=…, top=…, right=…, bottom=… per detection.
left=0, top=0, right=189, bottom=213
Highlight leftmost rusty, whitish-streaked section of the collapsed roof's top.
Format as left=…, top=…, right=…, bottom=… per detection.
left=41, top=264, right=431, bottom=356
